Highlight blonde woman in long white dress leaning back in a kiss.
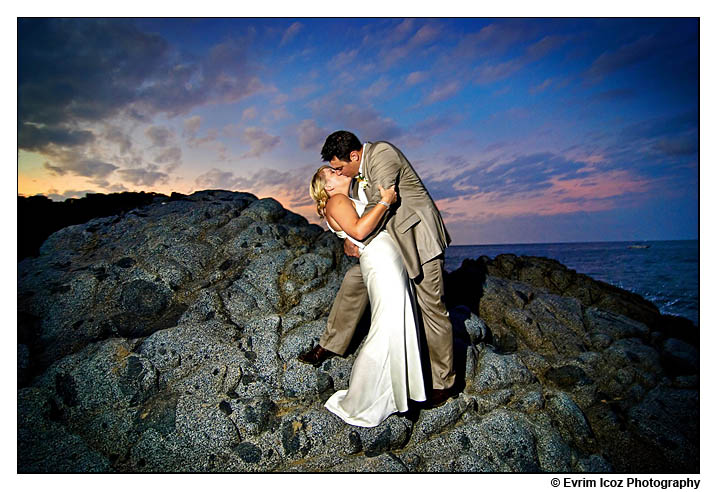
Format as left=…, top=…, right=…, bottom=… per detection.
left=310, top=166, right=426, bottom=427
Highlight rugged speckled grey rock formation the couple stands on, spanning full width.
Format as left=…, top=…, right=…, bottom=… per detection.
left=18, top=191, right=699, bottom=472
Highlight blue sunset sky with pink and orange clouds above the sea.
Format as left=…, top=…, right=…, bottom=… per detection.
left=17, top=17, right=699, bottom=244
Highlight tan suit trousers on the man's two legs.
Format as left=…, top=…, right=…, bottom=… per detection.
left=319, top=256, right=455, bottom=389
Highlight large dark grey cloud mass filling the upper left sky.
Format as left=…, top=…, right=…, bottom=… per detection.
left=18, top=18, right=263, bottom=151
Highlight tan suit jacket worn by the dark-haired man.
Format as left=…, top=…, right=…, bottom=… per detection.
left=354, top=142, right=451, bottom=278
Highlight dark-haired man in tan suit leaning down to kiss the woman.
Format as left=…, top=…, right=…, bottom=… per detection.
left=299, top=131, right=455, bottom=407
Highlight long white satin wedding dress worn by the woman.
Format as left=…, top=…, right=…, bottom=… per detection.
left=324, top=199, right=426, bottom=427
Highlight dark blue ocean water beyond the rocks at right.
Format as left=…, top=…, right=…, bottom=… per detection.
left=445, top=240, right=699, bottom=326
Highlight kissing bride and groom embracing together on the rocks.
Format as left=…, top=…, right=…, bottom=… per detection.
left=299, top=131, right=456, bottom=427
